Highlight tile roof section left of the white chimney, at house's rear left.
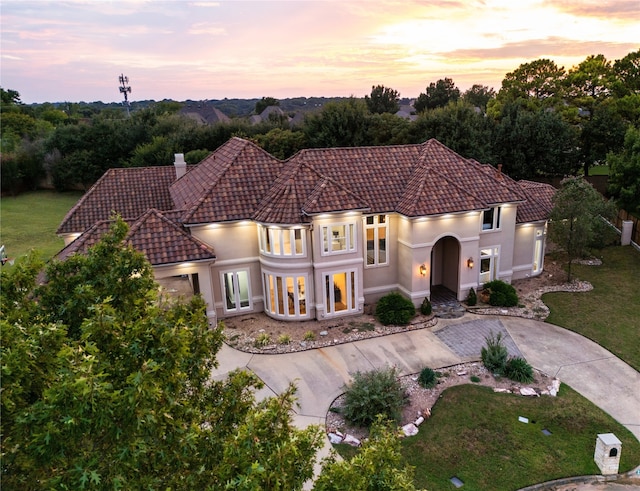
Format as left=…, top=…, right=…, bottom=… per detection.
left=57, top=165, right=176, bottom=234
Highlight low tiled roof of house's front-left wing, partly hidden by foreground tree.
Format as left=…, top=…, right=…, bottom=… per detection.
left=56, top=209, right=216, bottom=266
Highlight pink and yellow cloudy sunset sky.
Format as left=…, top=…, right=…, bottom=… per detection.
left=0, top=0, right=640, bottom=103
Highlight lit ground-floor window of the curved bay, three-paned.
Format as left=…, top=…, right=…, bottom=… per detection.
left=264, top=273, right=308, bottom=317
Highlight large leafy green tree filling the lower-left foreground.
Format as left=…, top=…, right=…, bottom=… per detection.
left=0, top=220, right=322, bottom=490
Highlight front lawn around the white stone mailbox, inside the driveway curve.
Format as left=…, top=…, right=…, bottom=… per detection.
left=336, top=384, right=640, bottom=491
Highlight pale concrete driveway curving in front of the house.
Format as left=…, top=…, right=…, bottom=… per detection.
left=213, top=314, right=640, bottom=440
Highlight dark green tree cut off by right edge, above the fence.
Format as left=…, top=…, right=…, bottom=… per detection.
left=607, top=126, right=640, bottom=213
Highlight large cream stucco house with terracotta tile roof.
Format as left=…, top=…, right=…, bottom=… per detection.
left=58, top=138, right=554, bottom=321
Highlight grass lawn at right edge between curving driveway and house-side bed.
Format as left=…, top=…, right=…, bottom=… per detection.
left=542, top=247, right=640, bottom=371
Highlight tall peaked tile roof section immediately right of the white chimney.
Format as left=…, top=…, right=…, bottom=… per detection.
left=170, top=137, right=283, bottom=224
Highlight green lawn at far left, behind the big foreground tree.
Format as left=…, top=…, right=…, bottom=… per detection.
left=0, top=191, right=82, bottom=268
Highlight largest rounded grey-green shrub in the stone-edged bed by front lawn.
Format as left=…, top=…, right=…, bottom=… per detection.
left=342, top=367, right=405, bottom=427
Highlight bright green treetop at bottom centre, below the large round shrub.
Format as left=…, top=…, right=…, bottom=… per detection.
left=313, top=417, right=416, bottom=491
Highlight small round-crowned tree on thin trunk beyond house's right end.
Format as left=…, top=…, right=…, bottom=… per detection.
left=549, top=177, right=615, bottom=281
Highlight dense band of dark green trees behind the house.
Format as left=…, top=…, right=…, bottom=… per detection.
left=2, top=50, right=640, bottom=211
